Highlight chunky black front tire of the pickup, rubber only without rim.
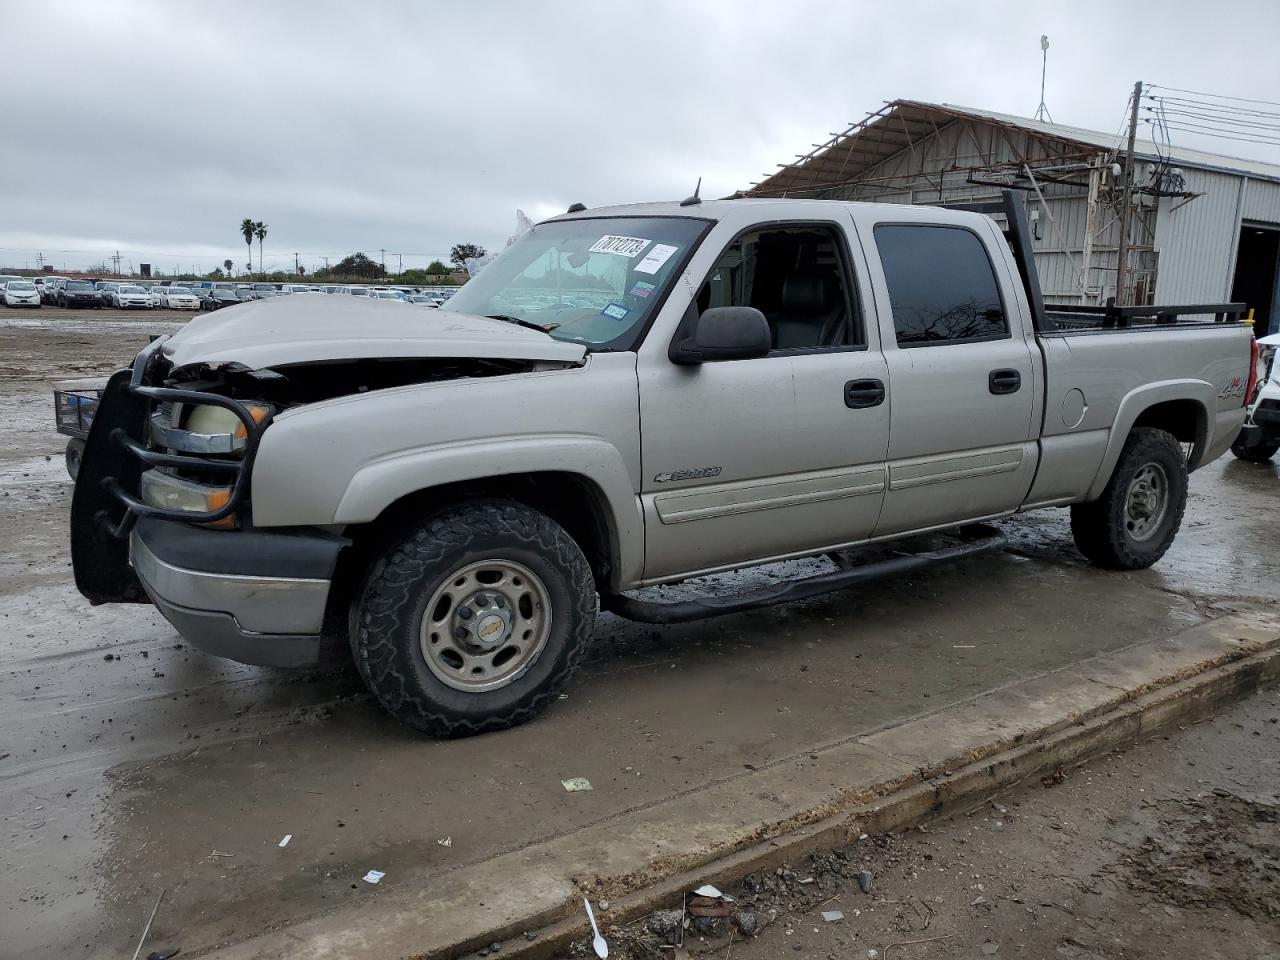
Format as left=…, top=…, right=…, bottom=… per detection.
left=351, top=500, right=596, bottom=737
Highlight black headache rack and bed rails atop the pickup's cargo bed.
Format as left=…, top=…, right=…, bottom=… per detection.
left=946, top=189, right=1248, bottom=333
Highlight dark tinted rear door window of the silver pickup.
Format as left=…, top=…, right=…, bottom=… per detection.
left=876, top=224, right=1009, bottom=347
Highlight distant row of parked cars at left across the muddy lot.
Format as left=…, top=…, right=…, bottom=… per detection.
left=0, top=275, right=453, bottom=310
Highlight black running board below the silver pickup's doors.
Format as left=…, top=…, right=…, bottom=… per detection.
left=600, top=525, right=1009, bottom=623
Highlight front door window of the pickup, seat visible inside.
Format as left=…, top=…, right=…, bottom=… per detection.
left=698, top=224, right=863, bottom=349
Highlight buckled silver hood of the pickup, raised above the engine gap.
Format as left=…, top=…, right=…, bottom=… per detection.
left=161, top=293, right=586, bottom=370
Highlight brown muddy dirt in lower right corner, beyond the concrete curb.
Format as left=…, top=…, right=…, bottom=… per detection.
left=570, top=691, right=1280, bottom=960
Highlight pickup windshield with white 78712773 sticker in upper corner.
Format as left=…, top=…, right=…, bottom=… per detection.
left=449, top=216, right=705, bottom=349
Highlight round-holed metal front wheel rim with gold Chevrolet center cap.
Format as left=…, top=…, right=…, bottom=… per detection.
left=419, top=559, right=552, bottom=694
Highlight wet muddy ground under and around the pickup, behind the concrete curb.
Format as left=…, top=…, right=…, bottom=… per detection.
left=0, top=310, right=1280, bottom=957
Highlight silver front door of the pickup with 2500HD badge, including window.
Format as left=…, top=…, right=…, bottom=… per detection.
left=639, top=221, right=890, bottom=581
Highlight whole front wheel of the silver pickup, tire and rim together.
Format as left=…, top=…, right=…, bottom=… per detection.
left=351, top=500, right=596, bottom=737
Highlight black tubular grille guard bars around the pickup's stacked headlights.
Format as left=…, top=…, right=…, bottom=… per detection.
left=86, top=338, right=270, bottom=539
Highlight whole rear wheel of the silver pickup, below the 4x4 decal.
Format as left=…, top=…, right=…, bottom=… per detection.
left=1071, top=428, right=1187, bottom=570
